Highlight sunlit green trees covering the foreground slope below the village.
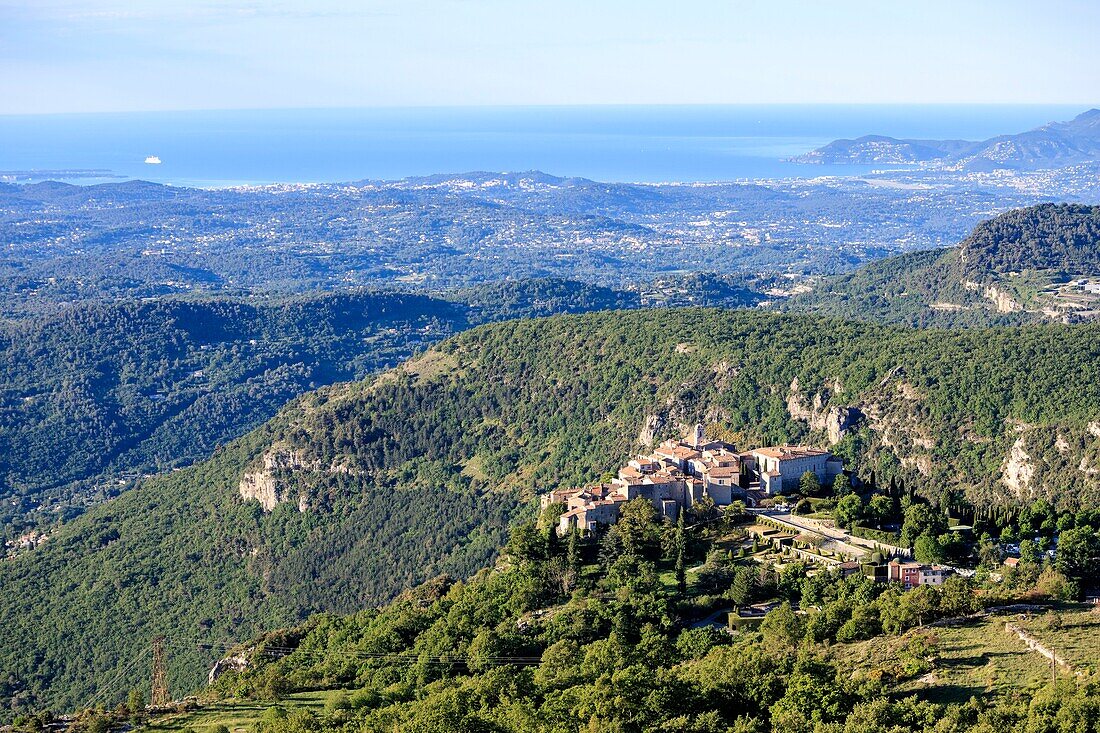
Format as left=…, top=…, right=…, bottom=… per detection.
left=90, top=499, right=1100, bottom=733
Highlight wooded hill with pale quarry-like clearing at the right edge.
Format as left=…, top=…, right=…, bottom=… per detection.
left=787, top=204, right=1100, bottom=326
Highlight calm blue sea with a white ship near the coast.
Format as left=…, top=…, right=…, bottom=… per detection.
left=0, top=105, right=1084, bottom=186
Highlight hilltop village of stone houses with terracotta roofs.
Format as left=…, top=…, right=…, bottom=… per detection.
left=542, top=425, right=844, bottom=534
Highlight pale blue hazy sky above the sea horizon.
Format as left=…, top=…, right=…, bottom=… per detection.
left=0, top=0, right=1100, bottom=113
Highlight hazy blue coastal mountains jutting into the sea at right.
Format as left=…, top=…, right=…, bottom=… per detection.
left=793, top=109, right=1100, bottom=171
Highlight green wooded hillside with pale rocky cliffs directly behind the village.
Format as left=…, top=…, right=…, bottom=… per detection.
left=0, top=309, right=1100, bottom=709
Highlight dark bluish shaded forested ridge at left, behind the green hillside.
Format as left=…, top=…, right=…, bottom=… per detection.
left=0, top=278, right=660, bottom=539
